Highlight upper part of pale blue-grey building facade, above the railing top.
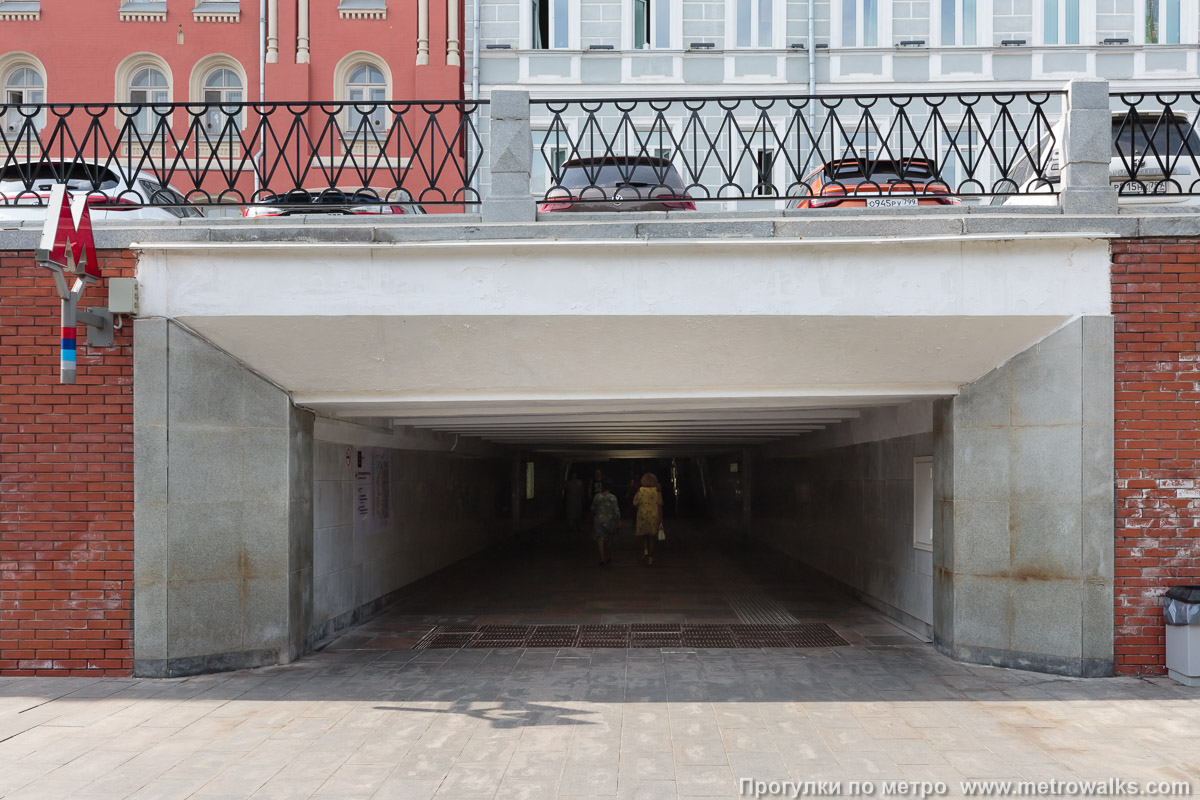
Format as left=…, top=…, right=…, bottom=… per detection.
left=466, top=0, right=1200, bottom=97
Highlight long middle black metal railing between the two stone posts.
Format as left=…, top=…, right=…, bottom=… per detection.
left=532, top=91, right=1064, bottom=207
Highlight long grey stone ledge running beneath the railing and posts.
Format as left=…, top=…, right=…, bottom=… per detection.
left=0, top=209, right=1200, bottom=249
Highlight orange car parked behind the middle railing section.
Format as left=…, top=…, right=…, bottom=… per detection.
left=787, top=158, right=960, bottom=209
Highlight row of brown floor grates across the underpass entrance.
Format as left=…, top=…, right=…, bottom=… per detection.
left=414, top=622, right=850, bottom=650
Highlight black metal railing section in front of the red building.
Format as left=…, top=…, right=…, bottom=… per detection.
left=0, top=101, right=482, bottom=216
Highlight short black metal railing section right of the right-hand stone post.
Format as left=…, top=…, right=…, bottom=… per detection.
left=1109, top=92, right=1200, bottom=196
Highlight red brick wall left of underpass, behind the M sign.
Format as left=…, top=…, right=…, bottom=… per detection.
left=0, top=252, right=134, bottom=675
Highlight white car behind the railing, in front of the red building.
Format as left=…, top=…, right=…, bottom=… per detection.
left=0, top=161, right=204, bottom=222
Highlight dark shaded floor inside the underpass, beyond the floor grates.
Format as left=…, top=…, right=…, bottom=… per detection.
left=332, top=523, right=912, bottom=649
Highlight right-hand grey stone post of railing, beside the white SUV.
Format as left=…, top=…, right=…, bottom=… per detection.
left=1060, top=79, right=1117, bottom=215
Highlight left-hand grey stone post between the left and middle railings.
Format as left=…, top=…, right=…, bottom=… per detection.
left=482, top=89, right=538, bottom=222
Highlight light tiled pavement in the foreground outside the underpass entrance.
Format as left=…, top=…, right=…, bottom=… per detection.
left=0, top=527, right=1200, bottom=800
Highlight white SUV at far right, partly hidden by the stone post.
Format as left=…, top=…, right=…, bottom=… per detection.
left=991, top=109, right=1200, bottom=205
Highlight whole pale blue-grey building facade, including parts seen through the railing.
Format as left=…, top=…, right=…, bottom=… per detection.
left=466, top=0, right=1200, bottom=209
